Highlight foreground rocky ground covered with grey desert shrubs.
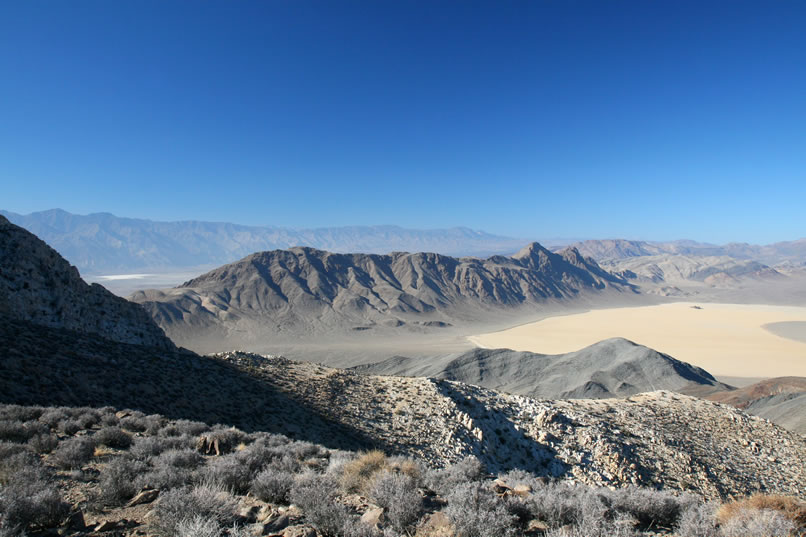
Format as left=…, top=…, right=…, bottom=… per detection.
left=0, top=401, right=806, bottom=537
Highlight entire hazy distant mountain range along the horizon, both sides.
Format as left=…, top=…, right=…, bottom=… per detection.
left=6, top=209, right=806, bottom=275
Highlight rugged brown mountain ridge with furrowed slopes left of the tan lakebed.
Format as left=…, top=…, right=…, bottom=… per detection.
left=131, top=239, right=634, bottom=349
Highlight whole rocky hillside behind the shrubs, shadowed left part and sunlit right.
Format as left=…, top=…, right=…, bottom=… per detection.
left=0, top=314, right=806, bottom=497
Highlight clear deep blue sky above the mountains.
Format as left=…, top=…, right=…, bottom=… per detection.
left=0, top=0, right=806, bottom=242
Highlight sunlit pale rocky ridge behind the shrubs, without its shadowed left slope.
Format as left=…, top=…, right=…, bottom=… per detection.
left=208, top=352, right=806, bottom=498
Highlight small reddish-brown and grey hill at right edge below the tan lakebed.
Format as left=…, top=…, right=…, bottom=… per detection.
left=707, top=377, right=806, bottom=435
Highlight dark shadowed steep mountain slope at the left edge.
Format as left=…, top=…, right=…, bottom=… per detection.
left=0, top=216, right=173, bottom=348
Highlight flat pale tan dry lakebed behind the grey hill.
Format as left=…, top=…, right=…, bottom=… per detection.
left=469, top=302, right=806, bottom=378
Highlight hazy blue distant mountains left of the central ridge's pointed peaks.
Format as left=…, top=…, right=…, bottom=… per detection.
left=0, top=209, right=523, bottom=274
